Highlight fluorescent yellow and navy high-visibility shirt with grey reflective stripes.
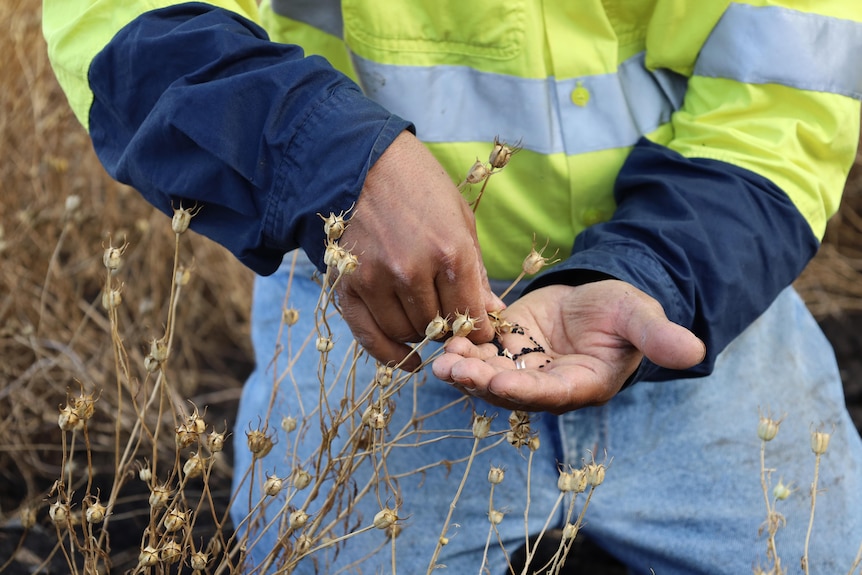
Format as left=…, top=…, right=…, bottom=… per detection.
left=44, top=0, right=862, bottom=384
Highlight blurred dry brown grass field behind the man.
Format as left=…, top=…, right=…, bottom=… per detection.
left=0, top=0, right=862, bottom=570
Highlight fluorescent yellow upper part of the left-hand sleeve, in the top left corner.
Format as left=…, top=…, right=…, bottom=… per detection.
left=42, top=0, right=257, bottom=128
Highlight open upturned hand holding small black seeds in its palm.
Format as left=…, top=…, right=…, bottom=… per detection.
left=433, top=280, right=706, bottom=414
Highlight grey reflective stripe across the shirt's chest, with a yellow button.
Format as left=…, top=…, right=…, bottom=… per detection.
left=353, top=54, right=687, bottom=154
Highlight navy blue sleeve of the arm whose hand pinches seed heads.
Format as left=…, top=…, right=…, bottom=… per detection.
left=89, top=3, right=412, bottom=274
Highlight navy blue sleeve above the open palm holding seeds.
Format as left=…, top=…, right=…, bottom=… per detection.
left=528, top=139, right=819, bottom=383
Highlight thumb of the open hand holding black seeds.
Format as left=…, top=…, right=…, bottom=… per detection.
left=624, top=302, right=706, bottom=369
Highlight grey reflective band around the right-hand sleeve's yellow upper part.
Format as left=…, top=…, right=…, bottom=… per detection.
left=694, top=4, right=862, bottom=99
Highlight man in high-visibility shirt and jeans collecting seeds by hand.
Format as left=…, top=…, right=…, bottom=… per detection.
left=45, top=0, right=862, bottom=573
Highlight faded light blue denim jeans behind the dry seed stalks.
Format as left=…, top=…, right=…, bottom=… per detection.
left=233, top=254, right=862, bottom=575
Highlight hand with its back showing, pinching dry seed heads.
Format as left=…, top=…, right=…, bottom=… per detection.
left=338, top=132, right=504, bottom=370
